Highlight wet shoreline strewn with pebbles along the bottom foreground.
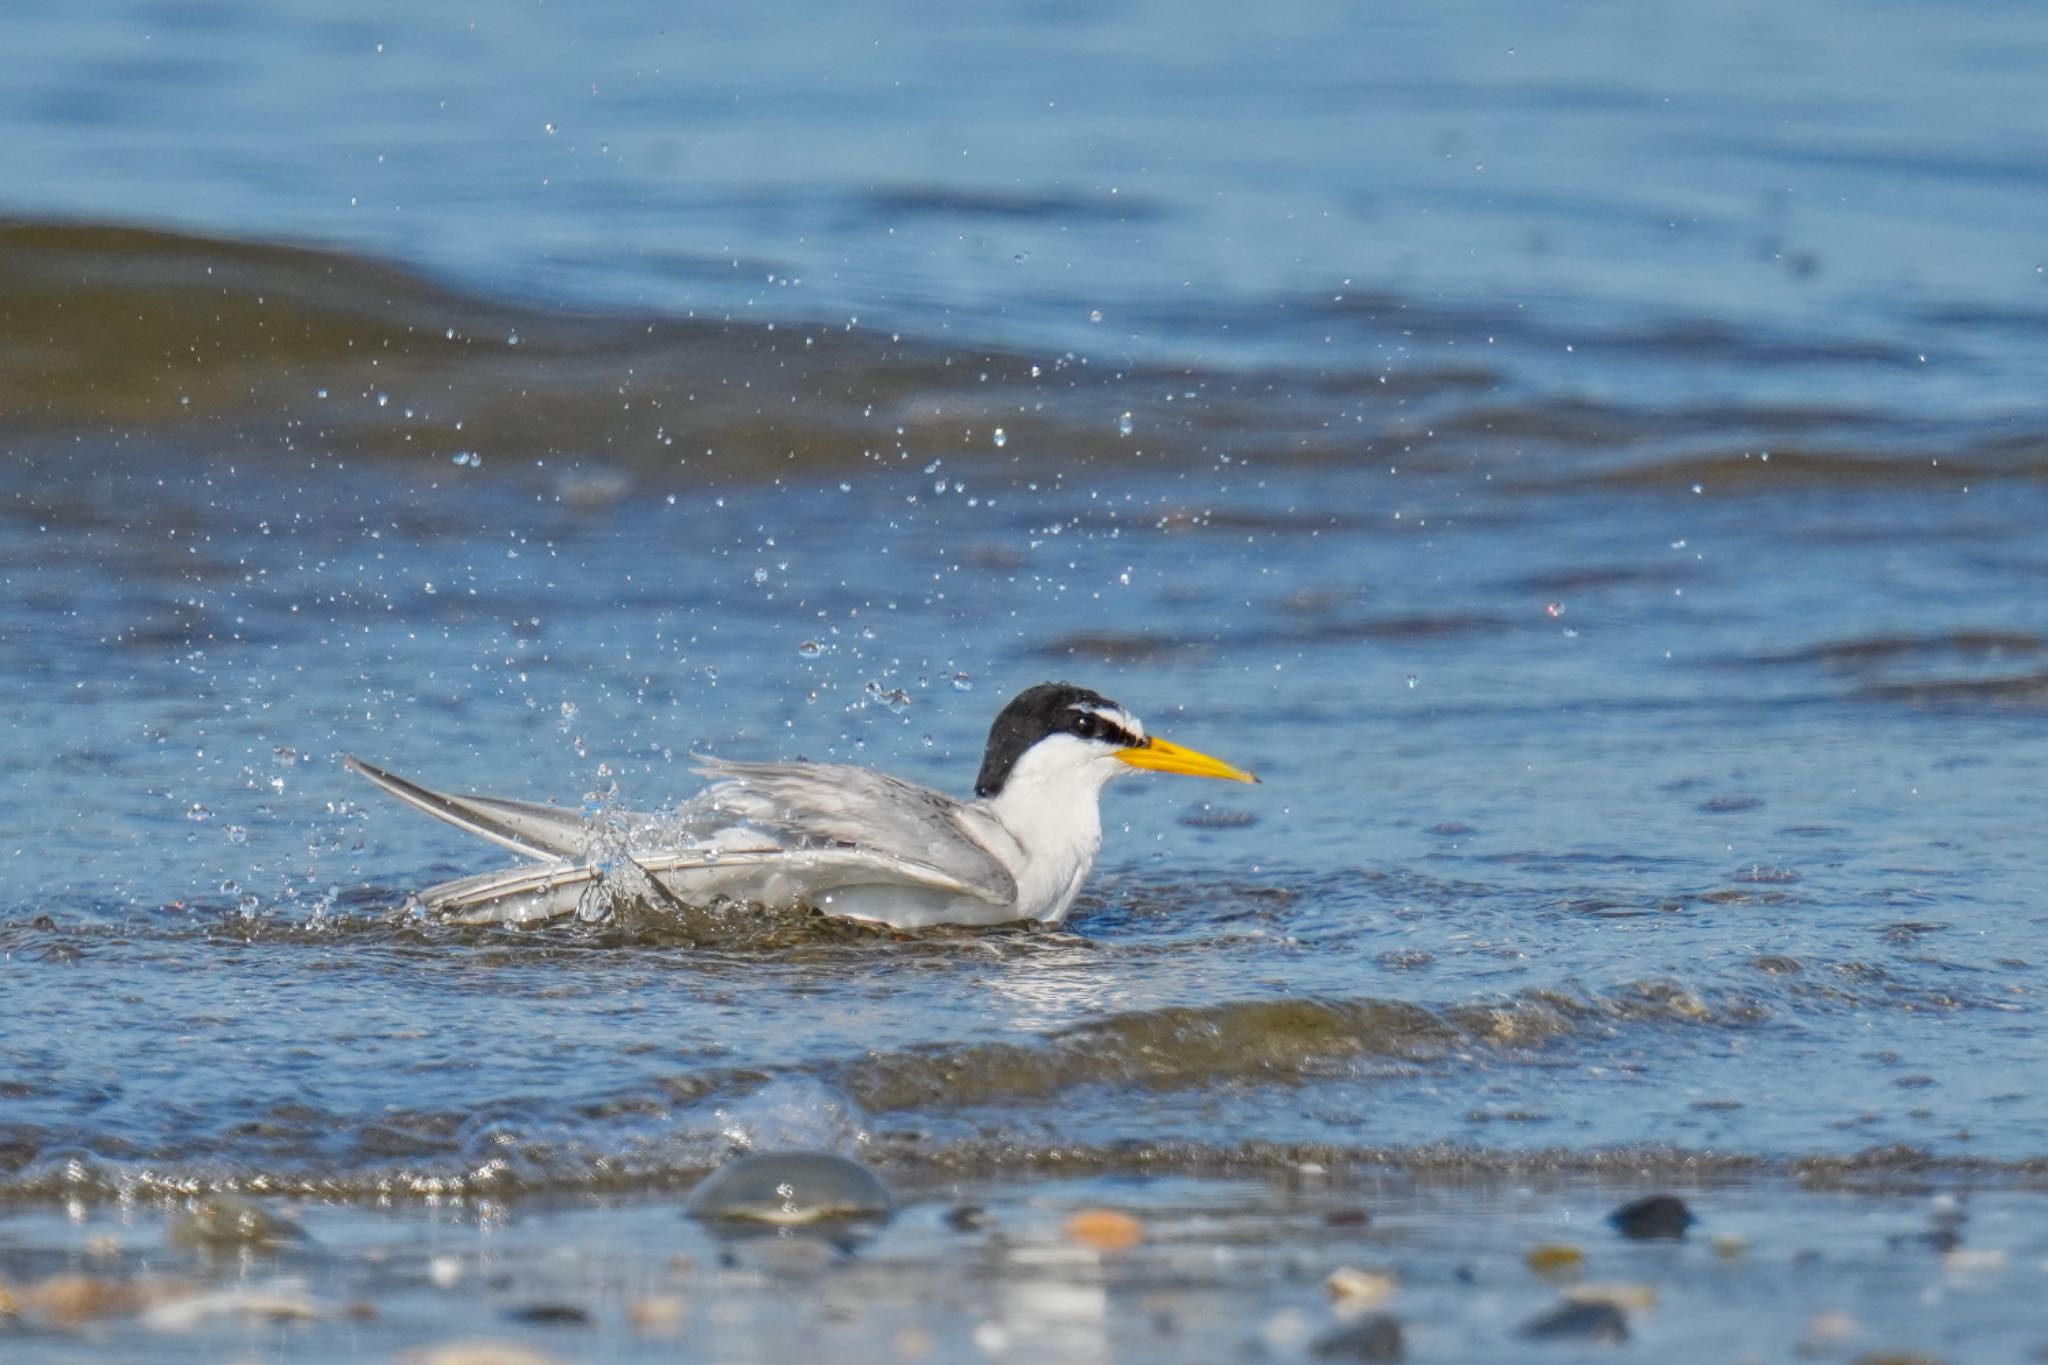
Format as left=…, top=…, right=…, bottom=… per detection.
left=0, top=1169, right=2048, bottom=1365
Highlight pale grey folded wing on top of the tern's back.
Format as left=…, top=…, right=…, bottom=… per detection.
left=682, top=759, right=1018, bottom=905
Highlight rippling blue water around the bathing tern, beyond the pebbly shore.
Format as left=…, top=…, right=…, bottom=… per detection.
left=0, top=0, right=2048, bottom=1219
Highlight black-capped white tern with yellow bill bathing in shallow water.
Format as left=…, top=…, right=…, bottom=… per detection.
left=346, top=681, right=1257, bottom=929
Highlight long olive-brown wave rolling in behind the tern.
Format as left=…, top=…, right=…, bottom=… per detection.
left=0, top=213, right=2048, bottom=497
